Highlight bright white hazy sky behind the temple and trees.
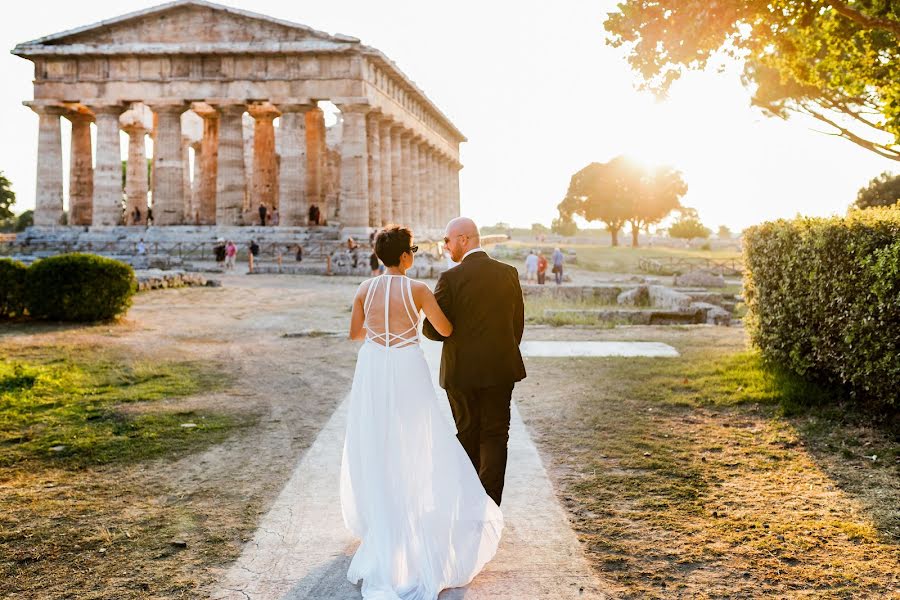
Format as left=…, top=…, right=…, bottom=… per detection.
left=0, top=0, right=900, bottom=231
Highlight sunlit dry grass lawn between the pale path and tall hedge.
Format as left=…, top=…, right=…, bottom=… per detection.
left=516, top=327, right=900, bottom=598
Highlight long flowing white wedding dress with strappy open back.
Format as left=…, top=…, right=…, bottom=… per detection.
left=341, top=275, right=503, bottom=600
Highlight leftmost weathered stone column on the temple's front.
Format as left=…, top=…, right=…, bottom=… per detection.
left=26, top=103, right=65, bottom=225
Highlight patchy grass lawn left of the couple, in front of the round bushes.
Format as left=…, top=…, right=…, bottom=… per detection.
left=0, top=346, right=253, bottom=598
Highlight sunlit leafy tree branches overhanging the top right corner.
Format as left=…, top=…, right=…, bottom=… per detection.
left=605, top=0, right=900, bottom=161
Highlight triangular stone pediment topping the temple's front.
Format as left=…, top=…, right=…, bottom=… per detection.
left=14, top=0, right=359, bottom=55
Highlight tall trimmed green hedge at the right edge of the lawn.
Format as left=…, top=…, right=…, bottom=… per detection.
left=744, top=208, right=900, bottom=406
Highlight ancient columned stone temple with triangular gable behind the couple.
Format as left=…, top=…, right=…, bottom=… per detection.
left=13, top=0, right=465, bottom=237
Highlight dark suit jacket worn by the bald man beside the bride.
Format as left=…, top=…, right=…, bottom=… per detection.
left=423, top=252, right=525, bottom=389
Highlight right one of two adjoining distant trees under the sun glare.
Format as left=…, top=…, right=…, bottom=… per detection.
left=628, top=166, right=687, bottom=248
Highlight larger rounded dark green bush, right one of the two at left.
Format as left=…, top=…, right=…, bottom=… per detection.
left=27, top=253, right=137, bottom=321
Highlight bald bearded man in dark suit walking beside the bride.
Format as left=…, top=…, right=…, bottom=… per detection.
left=423, top=217, right=525, bottom=506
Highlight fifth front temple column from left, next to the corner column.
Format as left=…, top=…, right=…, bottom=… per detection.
left=278, top=104, right=313, bottom=227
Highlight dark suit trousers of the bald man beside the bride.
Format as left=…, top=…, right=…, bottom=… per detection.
left=447, top=383, right=515, bottom=506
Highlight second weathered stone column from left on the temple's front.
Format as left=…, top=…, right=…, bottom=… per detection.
left=91, top=104, right=125, bottom=227
